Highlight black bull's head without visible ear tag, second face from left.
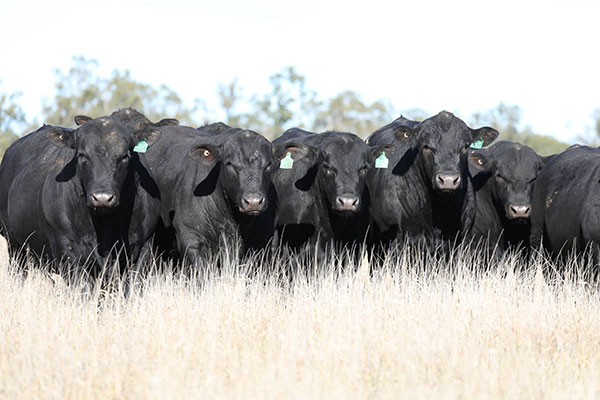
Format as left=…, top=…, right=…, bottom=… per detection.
left=190, top=130, right=272, bottom=216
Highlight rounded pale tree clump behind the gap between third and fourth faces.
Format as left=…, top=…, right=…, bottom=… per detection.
left=313, top=91, right=392, bottom=137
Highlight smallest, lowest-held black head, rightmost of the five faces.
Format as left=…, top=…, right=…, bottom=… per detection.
left=469, top=142, right=544, bottom=222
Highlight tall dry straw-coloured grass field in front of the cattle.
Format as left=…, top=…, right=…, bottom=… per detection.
left=0, top=236, right=600, bottom=399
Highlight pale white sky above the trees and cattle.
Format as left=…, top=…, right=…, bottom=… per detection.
left=0, top=0, right=600, bottom=141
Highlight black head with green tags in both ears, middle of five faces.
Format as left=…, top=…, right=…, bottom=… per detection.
left=275, top=132, right=394, bottom=216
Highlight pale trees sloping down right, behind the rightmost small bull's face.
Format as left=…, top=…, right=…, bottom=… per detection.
left=471, top=103, right=569, bottom=156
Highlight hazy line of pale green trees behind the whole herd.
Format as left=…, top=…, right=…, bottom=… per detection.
left=0, top=56, right=600, bottom=159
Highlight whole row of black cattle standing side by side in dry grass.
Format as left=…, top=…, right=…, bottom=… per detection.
left=0, top=109, right=600, bottom=274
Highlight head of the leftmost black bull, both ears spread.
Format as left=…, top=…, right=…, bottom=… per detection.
left=47, top=117, right=159, bottom=212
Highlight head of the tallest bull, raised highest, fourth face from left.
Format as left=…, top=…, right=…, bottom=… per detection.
left=395, top=111, right=498, bottom=194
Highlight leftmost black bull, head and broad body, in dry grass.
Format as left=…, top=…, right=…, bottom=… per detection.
left=0, top=117, right=159, bottom=272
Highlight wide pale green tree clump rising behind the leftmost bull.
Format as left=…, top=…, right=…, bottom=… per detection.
left=42, top=56, right=195, bottom=126
